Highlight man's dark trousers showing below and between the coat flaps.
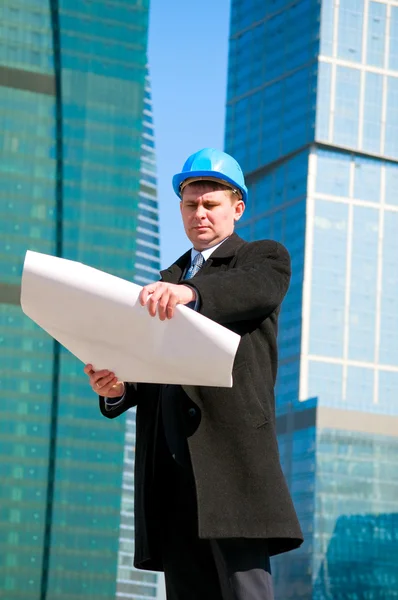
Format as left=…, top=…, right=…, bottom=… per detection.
left=156, top=448, right=274, bottom=600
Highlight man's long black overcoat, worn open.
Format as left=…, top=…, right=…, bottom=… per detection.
left=100, top=234, right=303, bottom=570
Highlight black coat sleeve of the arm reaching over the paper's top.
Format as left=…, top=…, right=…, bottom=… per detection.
left=181, top=240, right=291, bottom=324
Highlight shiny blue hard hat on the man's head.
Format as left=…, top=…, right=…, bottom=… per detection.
left=173, top=148, right=247, bottom=204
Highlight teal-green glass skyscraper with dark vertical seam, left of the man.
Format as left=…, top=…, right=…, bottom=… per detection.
left=0, top=0, right=159, bottom=600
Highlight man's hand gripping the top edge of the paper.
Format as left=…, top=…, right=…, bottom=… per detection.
left=140, top=281, right=196, bottom=321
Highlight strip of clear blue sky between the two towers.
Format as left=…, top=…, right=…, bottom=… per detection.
left=148, top=0, right=230, bottom=267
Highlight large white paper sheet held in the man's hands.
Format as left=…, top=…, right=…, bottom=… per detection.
left=21, top=251, right=240, bottom=387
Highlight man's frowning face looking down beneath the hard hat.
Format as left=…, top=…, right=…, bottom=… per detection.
left=180, top=183, right=245, bottom=250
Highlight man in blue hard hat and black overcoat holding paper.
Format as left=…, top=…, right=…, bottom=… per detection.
left=85, top=148, right=302, bottom=600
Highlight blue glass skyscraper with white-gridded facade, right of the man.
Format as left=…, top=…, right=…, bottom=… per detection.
left=226, top=0, right=398, bottom=600
